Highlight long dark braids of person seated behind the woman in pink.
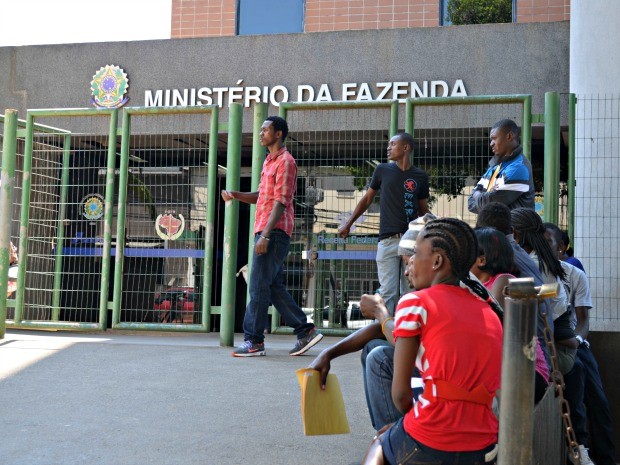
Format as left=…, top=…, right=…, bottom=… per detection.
left=510, top=207, right=566, bottom=280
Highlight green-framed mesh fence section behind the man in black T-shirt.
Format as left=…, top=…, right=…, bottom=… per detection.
left=266, top=94, right=572, bottom=333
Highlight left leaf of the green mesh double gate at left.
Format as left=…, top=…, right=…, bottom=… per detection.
left=12, top=109, right=117, bottom=329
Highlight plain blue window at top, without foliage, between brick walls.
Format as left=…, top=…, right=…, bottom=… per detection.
left=237, top=0, right=305, bottom=35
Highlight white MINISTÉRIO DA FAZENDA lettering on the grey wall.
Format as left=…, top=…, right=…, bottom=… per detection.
left=144, top=79, right=467, bottom=107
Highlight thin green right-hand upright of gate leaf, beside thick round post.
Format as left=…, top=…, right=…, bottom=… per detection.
left=202, top=107, right=220, bottom=332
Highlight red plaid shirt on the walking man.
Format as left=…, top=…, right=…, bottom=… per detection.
left=254, top=147, right=297, bottom=237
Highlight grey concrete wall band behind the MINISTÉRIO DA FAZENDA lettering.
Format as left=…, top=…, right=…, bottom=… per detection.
left=0, top=22, right=569, bottom=129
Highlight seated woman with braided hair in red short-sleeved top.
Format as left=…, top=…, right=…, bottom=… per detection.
left=363, top=218, right=502, bottom=465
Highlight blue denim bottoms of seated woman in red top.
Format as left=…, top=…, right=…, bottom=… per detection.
left=381, top=419, right=495, bottom=465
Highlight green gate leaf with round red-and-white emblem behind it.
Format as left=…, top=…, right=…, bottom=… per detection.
left=112, top=106, right=219, bottom=331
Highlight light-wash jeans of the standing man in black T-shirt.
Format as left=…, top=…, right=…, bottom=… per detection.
left=377, top=237, right=411, bottom=315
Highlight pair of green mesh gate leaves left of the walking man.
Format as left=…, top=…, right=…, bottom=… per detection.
left=1, top=107, right=219, bottom=331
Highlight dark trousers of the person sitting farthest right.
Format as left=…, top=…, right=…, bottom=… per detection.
left=564, top=344, right=616, bottom=465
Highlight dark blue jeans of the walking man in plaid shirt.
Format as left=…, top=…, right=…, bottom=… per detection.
left=243, top=229, right=314, bottom=344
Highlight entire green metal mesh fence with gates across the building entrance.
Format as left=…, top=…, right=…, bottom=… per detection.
left=0, top=95, right=574, bottom=338
